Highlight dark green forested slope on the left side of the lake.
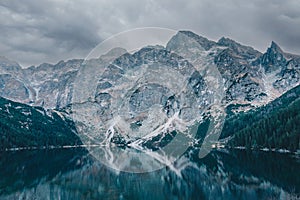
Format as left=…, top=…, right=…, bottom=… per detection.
left=0, top=97, right=81, bottom=149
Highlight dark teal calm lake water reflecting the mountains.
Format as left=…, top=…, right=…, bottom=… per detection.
left=0, top=148, right=300, bottom=200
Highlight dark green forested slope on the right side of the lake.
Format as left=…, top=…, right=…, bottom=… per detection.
left=222, top=86, right=300, bottom=151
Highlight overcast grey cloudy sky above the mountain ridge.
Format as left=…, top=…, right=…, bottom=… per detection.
left=0, top=0, right=300, bottom=67
